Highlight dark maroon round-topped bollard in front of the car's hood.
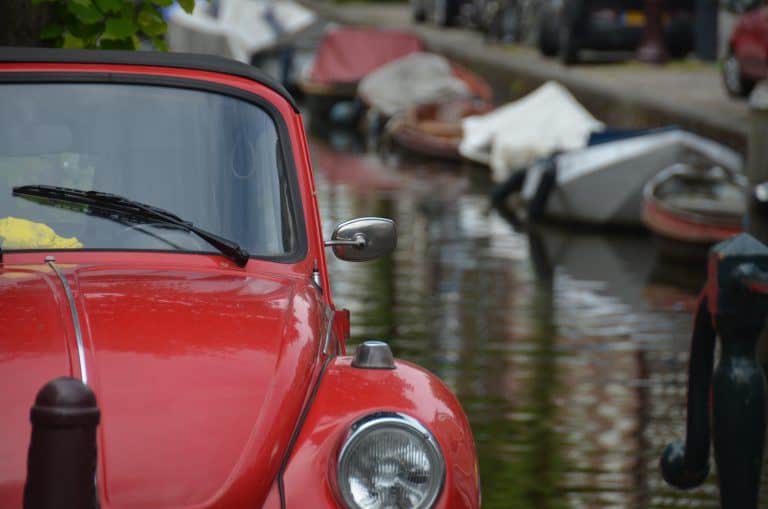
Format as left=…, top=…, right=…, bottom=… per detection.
left=24, top=377, right=100, bottom=509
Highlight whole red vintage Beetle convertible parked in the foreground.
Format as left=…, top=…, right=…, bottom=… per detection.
left=0, top=49, right=480, bottom=509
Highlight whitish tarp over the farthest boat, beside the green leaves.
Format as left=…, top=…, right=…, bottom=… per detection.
left=168, top=0, right=316, bottom=63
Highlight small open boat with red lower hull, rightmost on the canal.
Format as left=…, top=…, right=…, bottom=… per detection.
left=643, top=164, right=748, bottom=256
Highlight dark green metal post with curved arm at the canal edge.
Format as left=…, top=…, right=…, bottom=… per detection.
left=661, top=234, right=768, bottom=509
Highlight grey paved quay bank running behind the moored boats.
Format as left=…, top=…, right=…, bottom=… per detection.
left=304, top=0, right=749, bottom=153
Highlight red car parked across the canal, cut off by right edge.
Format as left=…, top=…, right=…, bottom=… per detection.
left=723, top=0, right=768, bottom=97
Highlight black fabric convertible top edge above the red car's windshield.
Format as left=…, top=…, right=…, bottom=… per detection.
left=0, top=47, right=299, bottom=112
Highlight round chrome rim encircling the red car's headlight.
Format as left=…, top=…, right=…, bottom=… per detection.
left=336, top=412, right=446, bottom=509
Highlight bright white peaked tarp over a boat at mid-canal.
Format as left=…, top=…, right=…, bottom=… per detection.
left=459, top=81, right=604, bottom=182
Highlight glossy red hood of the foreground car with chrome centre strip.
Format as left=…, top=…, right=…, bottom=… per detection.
left=0, top=265, right=324, bottom=508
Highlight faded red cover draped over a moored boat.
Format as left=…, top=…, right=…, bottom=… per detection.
left=310, top=28, right=423, bottom=85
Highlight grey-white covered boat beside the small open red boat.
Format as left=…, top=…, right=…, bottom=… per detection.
left=496, top=128, right=743, bottom=226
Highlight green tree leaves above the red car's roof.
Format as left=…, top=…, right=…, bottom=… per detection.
left=31, top=0, right=195, bottom=51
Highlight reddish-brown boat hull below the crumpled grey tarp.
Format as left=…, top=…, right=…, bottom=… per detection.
left=389, top=100, right=491, bottom=161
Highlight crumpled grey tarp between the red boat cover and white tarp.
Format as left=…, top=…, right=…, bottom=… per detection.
left=358, top=53, right=472, bottom=116
